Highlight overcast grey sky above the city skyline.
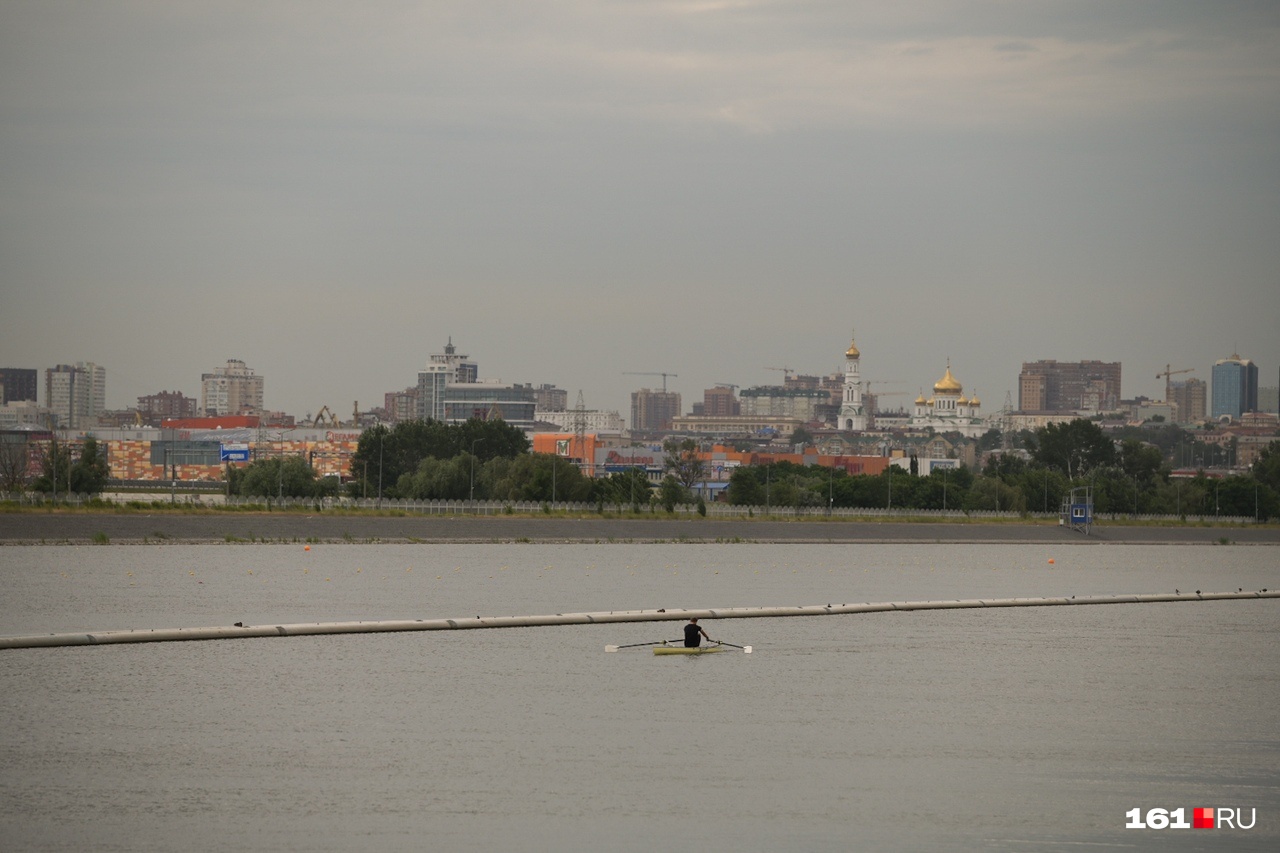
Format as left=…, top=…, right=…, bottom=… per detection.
left=0, top=0, right=1280, bottom=418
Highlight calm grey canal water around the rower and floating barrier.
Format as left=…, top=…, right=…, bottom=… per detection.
left=0, top=544, right=1280, bottom=852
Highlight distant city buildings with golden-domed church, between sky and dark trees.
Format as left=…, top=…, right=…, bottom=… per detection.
left=0, top=338, right=1280, bottom=480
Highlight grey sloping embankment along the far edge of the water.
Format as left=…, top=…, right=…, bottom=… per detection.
left=0, top=512, right=1280, bottom=546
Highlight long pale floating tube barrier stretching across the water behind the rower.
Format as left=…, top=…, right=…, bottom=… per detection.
left=0, top=589, right=1280, bottom=649
